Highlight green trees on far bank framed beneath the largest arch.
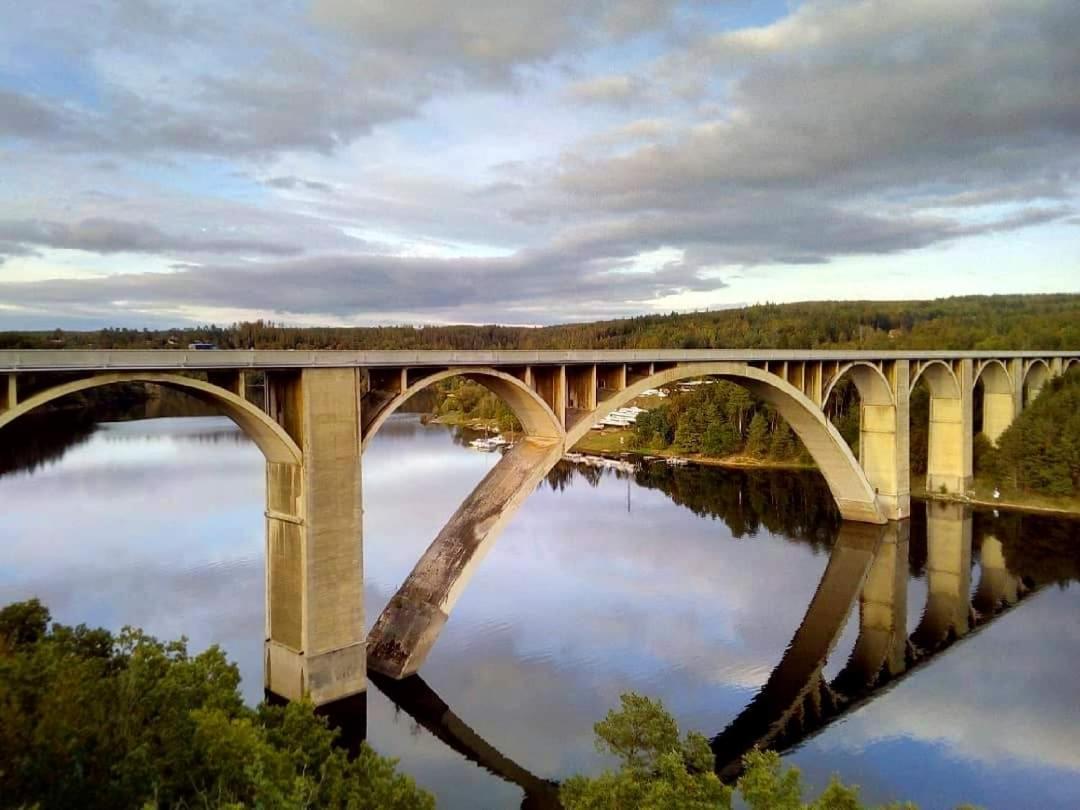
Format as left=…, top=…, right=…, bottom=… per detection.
left=631, top=380, right=810, bottom=463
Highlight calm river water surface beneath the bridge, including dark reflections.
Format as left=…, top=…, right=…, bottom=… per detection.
left=0, top=415, right=1080, bottom=808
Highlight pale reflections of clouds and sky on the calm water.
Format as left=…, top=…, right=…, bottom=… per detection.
left=0, top=417, right=1080, bottom=808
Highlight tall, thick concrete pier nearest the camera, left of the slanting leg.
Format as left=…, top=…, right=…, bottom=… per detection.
left=265, top=368, right=366, bottom=705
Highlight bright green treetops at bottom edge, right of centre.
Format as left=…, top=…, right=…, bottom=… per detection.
left=559, top=692, right=976, bottom=810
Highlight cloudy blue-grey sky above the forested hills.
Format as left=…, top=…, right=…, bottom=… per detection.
left=0, top=0, right=1080, bottom=328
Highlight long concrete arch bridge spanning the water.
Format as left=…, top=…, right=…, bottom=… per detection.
left=0, top=350, right=1080, bottom=704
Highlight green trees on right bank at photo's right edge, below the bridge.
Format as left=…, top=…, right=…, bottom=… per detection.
left=981, top=368, right=1080, bottom=496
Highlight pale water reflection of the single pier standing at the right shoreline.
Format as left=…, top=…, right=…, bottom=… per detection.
left=913, top=501, right=971, bottom=649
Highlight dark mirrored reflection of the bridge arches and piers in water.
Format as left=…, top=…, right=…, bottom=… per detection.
left=319, top=501, right=1061, bottom=809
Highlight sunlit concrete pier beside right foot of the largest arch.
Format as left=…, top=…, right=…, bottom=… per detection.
left=859, top=360, right=912, bottom=521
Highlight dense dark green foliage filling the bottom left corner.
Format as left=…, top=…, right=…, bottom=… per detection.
left=0, top=600, right=434, bottom=810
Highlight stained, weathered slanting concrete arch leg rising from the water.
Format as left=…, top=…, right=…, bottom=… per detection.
left=368, top=437, right=563, bottom=678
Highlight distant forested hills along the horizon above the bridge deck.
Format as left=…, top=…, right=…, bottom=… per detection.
left=0, top=295, right=1080, bottom=350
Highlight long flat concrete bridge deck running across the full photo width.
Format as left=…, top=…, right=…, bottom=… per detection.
left=0, top=349, right=1077, bottom=373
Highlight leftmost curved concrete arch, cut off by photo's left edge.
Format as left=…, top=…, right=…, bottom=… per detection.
left=0, top=372, right=303, bottom=464
